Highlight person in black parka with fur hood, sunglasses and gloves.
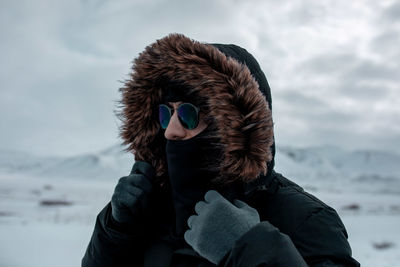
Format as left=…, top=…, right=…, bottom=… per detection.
left=82, top=34, right=359, bottom=267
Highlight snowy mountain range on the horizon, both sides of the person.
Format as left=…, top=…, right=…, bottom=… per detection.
left=0, top=145, right=400, bottom=193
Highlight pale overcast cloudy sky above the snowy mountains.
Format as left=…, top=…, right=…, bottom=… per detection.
left=0, top=0, right=400, bottom=155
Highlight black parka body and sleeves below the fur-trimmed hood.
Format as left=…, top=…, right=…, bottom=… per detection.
left=82, top=172, right=359, bottom=267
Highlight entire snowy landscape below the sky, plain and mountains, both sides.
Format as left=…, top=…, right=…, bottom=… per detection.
left=0, top=146, right=400, bottom=267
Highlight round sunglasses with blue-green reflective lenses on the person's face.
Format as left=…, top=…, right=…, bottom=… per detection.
left=158, top=103, right=200, bottom=130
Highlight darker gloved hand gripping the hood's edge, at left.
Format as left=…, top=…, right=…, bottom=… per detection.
left=111, top=161, right=156, bottom=224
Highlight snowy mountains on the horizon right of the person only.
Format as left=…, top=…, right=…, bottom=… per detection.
left=275, top=146, right=400, bottom=194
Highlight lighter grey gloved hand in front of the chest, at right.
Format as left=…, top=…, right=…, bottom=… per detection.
left=184, top=190, right=260, bottom=264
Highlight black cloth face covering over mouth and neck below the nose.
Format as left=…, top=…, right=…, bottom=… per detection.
left=166, top=130, right=220, bottom=236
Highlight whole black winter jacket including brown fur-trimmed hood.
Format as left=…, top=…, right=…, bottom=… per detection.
left=82, top=34, right=359, bottom=267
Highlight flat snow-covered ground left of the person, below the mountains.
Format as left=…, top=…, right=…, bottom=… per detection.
left=0, top=175, right=115, bottom=267
